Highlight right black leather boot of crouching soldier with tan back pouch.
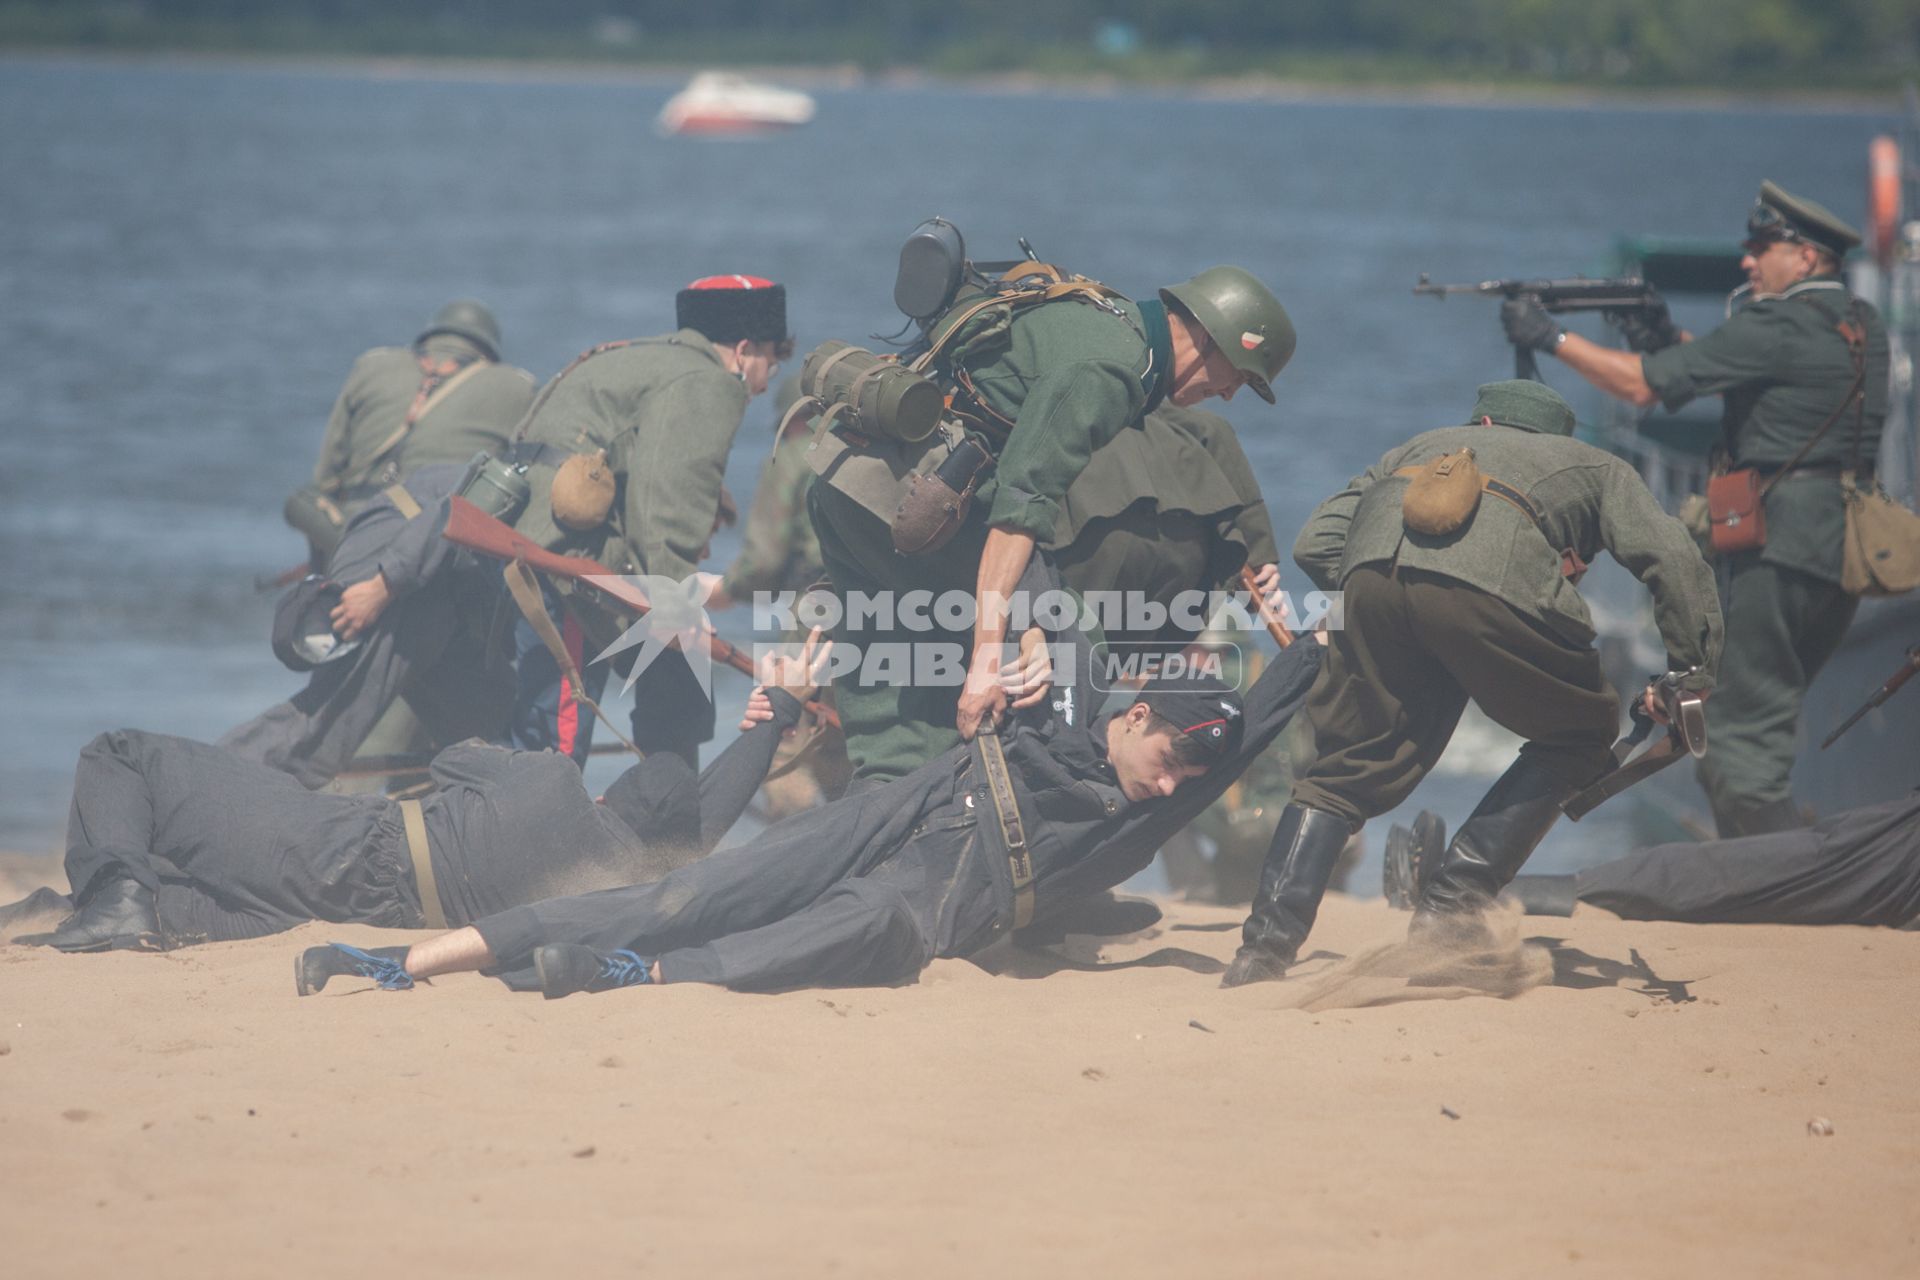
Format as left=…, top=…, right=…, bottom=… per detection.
left=1413, top=754, right=1580, bottom=935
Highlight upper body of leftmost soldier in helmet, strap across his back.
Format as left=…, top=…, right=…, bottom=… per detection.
left=286, top=299, right=534, bottom=572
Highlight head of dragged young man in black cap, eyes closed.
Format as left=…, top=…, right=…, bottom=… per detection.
left=1106, top=676, right=1246, bottom=800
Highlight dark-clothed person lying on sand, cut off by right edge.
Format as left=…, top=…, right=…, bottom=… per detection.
left=1386, top=791, right=1920, bottom=929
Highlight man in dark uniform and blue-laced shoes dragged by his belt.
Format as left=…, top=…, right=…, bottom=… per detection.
left=296, top=641, right=1321, bottom=998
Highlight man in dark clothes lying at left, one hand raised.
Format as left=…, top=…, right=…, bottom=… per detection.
left=0, top=639, right=826, bottom=955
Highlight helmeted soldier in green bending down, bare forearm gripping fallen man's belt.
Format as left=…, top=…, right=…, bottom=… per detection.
left=808, top=242, right=1294, bottom=785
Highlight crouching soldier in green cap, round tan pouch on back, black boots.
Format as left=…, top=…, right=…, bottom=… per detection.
left=1223, top=382, right=1720, bottom=986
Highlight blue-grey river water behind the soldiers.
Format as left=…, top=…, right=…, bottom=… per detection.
left=0, top=59, right=1893, bottom=883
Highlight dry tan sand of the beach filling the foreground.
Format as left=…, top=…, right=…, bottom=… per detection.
left=0, top=864, right=1920, bottom=1280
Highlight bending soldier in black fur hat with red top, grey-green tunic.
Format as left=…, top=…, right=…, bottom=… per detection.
left=509, top=274, right=793, bottom=764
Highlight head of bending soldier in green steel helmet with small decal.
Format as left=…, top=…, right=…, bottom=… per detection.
left=1160, top=267, right=1294, bottom=405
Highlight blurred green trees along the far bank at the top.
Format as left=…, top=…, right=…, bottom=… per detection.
left=0, top=0, right=1920, bottom=90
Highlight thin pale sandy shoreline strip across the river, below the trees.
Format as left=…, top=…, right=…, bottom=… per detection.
left=0, top=46, right=1903, bottom=115
